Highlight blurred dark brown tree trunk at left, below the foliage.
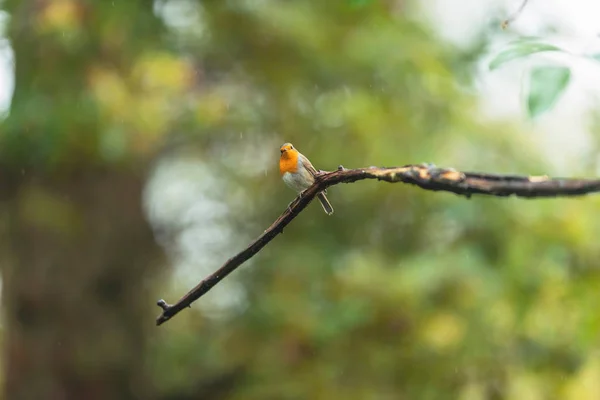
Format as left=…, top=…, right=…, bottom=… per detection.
left=4, top=171, right=157, bottom=399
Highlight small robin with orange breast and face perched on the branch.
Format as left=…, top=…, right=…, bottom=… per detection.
left=279, top=143, right=333, bottom=215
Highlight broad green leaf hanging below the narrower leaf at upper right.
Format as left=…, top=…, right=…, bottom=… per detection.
left=527, top=67, right=571, bottom=118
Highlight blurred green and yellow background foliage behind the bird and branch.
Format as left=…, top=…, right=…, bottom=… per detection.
left=0, top=0, right=600, bottom=400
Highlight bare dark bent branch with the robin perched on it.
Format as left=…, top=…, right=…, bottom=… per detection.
left=156, top=164, right=600, bottom=325
